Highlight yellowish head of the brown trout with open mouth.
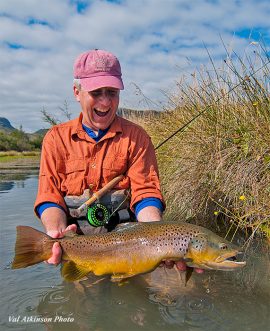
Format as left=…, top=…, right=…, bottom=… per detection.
left=184, top=232, right=246, bottom=270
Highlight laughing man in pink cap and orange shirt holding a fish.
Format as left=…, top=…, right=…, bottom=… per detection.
left=35, top=50, right=164, bottom=264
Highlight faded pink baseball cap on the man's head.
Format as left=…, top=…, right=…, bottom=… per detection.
left=74, top=49, right=124, bottom=91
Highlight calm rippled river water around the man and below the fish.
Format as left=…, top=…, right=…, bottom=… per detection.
left=0, top=174, right=270, bottom=331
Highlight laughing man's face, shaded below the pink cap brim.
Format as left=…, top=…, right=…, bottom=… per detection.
left=74, top=86, right=119, bottom=131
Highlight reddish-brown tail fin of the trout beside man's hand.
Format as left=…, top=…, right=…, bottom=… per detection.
left=12, top=226, right=54, bottom=269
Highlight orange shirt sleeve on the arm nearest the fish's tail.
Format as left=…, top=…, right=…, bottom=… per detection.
left=34, top=130, right=67, bottom=216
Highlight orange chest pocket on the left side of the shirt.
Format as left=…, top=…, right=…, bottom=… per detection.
left=56, top=158, right=86, bottom=195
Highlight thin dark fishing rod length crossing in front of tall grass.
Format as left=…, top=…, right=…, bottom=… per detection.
left=155, top=60, right=270, bottom=150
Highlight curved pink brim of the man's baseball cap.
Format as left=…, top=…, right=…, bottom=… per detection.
left=80, top=76, right=124, bottom=91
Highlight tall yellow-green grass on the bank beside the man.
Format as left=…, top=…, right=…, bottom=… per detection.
left=137, top=45, right=270, bottom=237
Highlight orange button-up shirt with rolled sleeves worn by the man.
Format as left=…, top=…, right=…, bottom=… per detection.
left=34, top=114, right=164, bottom=217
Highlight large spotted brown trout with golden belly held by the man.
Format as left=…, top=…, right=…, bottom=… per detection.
left=12, top=222, right=246, bottom=281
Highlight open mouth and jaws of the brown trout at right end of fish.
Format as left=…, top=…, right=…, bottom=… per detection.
left=205, top=251, right=246, bottom=271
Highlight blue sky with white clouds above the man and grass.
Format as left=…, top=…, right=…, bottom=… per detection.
left=0, top=0, right=270, bottom=132
